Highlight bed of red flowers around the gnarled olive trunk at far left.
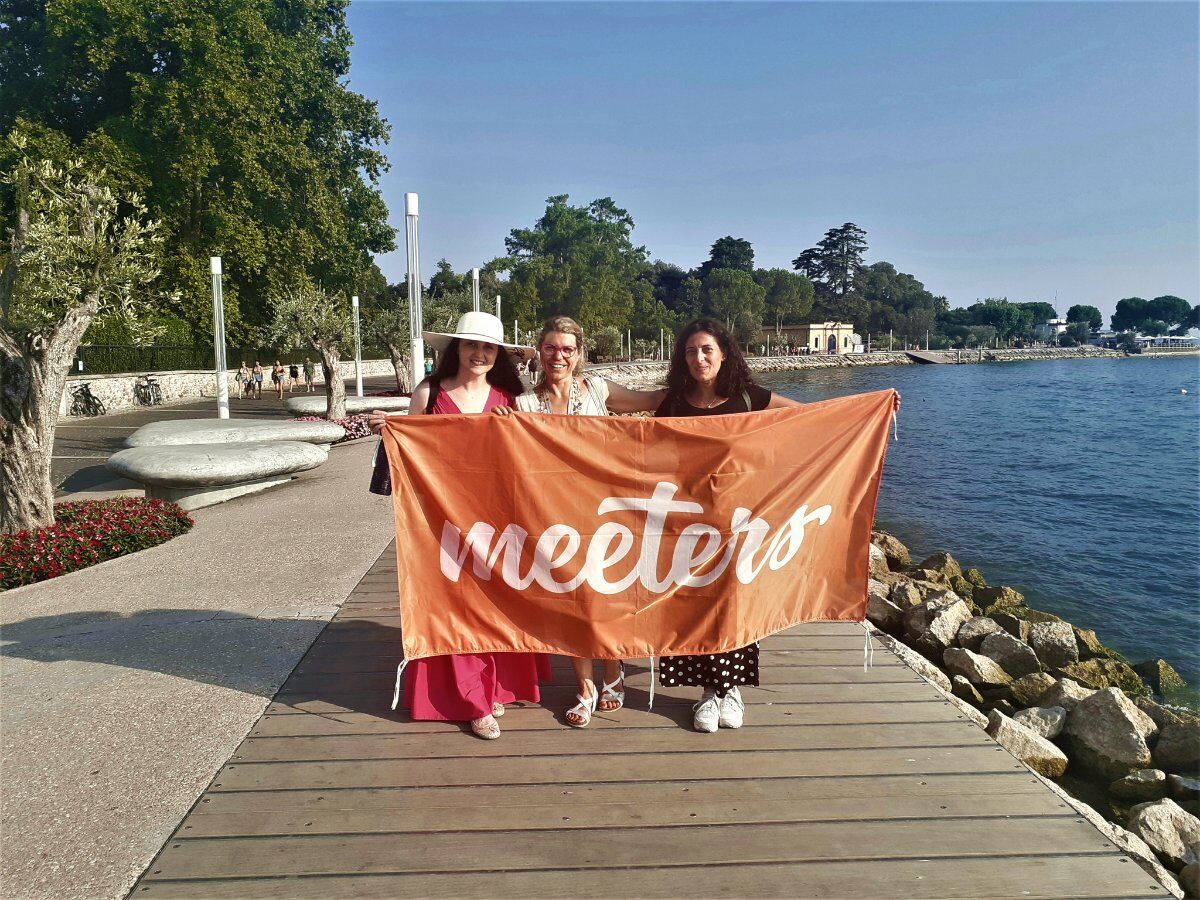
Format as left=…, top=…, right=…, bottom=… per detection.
left=0, top=497, right=194, bottom=590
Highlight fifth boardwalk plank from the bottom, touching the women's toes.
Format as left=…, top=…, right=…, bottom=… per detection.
left=226, top=721, right=995, bottom=762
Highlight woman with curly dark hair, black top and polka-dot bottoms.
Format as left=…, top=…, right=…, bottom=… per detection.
left=654, top=319, right=799, bottom=732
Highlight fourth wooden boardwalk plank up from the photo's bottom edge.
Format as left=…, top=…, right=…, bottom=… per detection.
left=210, top=734, right=1024, bottom=791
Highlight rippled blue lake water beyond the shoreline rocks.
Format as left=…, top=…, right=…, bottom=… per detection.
left=763, top=356, right=1200, bottom=685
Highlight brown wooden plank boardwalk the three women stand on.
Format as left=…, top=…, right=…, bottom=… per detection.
left=130, top=550, right=1166, bottom=898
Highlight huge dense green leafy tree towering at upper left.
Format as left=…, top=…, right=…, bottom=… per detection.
left=0, top=0, right=395, bottom=341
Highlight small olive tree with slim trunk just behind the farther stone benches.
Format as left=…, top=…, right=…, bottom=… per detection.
left=266, top=281, right=354, bottom=420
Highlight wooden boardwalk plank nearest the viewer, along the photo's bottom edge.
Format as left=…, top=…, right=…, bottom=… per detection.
left=133, top=853, right=1165, bottom=900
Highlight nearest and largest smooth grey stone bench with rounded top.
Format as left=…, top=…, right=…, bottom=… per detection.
left=104, top=440, right=329, bottom=509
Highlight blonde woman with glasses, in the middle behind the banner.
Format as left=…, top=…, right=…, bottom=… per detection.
left=493, top=316, right=666, bottom=728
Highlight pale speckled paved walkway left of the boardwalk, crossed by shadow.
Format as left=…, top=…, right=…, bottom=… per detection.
left=0, top=441, right=395, bottom=900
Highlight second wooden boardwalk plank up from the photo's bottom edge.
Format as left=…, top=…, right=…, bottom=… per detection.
left=140, top=809, right=1132, bottom=878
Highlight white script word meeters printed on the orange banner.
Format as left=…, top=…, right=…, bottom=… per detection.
left=440, top=481, right=833, bottom=594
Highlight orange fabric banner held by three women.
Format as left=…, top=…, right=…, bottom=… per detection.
left=383, top=390, right=898, bottom=659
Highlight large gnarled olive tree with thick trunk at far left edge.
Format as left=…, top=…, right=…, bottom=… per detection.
left=0, top=150, right=161, bottom=533
